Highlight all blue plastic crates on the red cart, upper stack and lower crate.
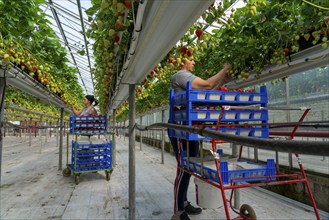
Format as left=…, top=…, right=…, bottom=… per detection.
left=169, top=82, right=276, bottom=184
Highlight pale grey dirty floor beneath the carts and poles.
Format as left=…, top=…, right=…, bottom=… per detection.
left=0, top=136, right=329, bottom=219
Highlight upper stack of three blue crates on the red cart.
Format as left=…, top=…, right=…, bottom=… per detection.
left=169, top=82, right=269, bottom=140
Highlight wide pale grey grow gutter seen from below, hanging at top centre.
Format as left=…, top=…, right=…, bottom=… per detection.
left=107, top=0, right=213, bottom=114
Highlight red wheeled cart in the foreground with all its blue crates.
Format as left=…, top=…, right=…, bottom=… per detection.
left=168, top=82, right=319, bottom=219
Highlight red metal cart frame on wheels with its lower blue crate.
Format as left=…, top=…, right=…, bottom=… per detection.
left=174, top=106, right=320, bottom=219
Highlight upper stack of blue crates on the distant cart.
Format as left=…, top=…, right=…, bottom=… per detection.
left=70, top=115, right=107, bottom=134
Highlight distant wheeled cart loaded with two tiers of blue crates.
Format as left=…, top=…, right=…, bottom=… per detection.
left=68, top=115, right=112, bottom=184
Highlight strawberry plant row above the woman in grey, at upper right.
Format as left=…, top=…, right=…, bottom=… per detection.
left=114, top=0, right=329, bottom=120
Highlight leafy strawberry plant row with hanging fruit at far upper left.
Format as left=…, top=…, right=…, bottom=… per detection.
left=0, top=0, right=83, bottom=110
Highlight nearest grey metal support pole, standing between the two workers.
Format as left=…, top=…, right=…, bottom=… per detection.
left=129, top=85, right=136, bottom=220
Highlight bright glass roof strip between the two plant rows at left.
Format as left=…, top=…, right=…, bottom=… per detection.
left=42, top=0, right=94, bottom=94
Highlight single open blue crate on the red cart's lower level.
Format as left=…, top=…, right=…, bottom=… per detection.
left=181, top=157, right=276, bottom=184
